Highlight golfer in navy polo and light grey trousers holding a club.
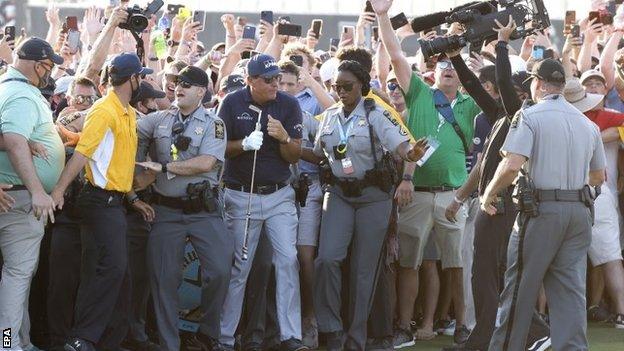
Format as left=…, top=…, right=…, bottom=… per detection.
left=218, top=55, right=305, bottom=351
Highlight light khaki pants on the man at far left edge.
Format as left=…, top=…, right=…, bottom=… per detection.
left=0, top=190, right=44, bottom=350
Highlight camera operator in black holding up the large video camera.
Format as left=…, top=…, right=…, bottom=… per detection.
left=445, top=18, right=550, bottom=351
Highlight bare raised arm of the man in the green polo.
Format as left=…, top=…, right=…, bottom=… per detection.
left=371, top=0, right=412, bottom=91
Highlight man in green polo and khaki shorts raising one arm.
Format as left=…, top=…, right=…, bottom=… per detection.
left=371, top=0, right=480, bottom=347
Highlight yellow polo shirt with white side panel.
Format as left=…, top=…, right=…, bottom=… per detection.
left=75, top=90, right=137, bottom=193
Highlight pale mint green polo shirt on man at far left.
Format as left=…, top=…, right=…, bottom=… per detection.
left=0, top=67, right=65, bottom=193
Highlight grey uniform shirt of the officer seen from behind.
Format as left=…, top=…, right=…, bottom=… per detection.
left=501, top=95, right=606, bottom=190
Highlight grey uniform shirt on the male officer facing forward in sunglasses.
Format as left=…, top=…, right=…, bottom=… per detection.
left=137, top=107, right=227, bottom=197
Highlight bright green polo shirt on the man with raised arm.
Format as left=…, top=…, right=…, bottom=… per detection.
left=404, top=73, right=481, bottom=187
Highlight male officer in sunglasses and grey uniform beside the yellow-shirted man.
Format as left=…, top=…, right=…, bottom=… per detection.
left=135, top=66, right=234, bottom=351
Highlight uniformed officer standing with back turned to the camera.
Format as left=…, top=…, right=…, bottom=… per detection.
left=481, top=57, right=606, bottom=350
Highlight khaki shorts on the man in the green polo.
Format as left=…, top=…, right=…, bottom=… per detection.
left=399, top=191, right=467, bottom=269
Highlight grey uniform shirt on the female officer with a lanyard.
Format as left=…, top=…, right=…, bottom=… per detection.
left=314, top=98, right=409, bottom=179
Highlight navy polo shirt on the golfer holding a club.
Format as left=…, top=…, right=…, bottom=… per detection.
left=217, top=87, right=303, bottom=185
